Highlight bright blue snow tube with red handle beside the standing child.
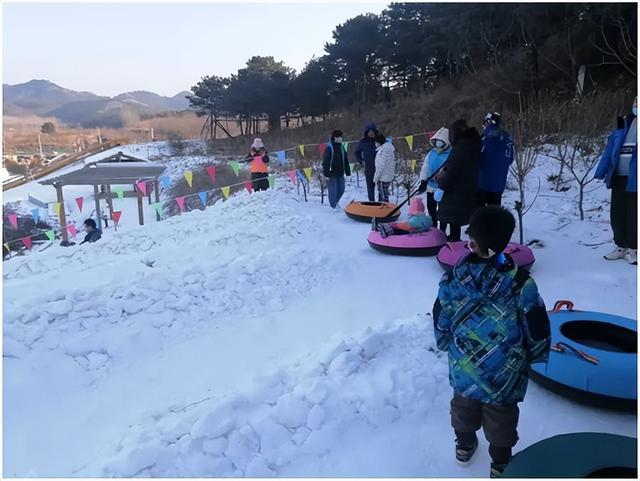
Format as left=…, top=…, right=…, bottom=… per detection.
left=531, top=301, right=638, bottom=410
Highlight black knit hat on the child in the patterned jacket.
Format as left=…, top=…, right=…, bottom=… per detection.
left=467, top=205, right=516, bottom=255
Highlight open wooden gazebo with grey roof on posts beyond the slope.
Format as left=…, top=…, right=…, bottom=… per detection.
left=39, top=152, right=166, bottom=240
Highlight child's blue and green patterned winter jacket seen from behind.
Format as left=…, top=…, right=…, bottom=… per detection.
left=433, top=254, right=551, bottom=405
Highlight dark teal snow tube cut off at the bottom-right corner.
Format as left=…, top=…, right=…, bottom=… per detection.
left=502, top=433, right=638, bottom=478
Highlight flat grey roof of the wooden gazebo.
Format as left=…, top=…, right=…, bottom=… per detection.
left=39, top=161, right=167, bottom=185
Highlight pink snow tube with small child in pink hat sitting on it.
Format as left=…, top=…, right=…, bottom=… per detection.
left=367, top=227, right=447, bottom=256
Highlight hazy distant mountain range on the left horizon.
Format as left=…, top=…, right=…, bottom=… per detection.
left=2, top=80, right=190, bottom=127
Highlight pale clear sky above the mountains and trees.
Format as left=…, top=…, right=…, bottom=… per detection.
left=2, top=2, right=385, bottom=95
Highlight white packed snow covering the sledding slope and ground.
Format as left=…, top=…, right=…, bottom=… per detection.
left=3, top=158, right=636, bottom=477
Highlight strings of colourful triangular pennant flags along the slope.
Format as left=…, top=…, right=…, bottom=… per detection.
left=4, top=127, right=433, bottom=250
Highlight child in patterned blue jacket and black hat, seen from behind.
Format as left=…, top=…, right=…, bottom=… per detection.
left=433, top=206, right=550, bottom=478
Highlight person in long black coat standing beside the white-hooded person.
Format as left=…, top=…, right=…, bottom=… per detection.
left=436, top=119, right=482, bottom=242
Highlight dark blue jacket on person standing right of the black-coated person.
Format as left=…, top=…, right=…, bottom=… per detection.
left=478, top=125, right=514, bottom=193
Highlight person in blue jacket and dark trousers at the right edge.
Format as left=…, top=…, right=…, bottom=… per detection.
left=594, top=98, right=638, bottom=265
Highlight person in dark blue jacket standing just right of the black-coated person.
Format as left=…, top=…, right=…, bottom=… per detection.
left=476, top=112, right=514, bottom=207
